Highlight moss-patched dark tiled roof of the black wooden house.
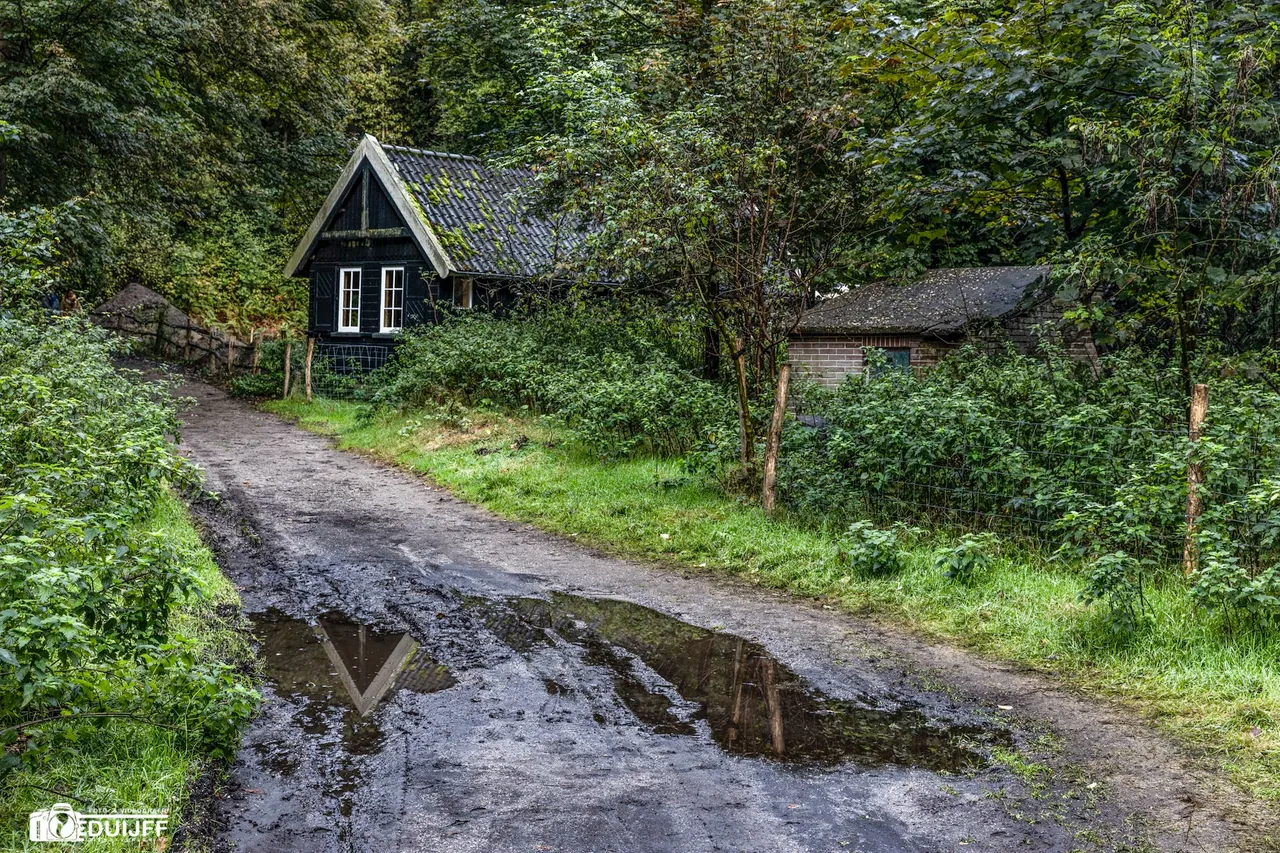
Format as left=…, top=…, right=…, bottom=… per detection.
left=285, top=136, right=582, bottom=278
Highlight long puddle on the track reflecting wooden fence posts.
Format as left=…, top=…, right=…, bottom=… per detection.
left=486, top=593, right=1011, bottom=772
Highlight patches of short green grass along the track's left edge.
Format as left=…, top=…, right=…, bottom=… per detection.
left=0, top=494, right=253, bottom=853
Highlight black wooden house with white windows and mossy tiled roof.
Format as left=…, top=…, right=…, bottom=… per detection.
left=284, top=136, right=580, bottom=366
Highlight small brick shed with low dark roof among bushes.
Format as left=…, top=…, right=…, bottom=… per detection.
left=787, top=266, right=1097, bottom=387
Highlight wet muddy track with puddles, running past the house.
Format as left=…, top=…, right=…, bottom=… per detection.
left=170, top=380, right=1267, bottom=853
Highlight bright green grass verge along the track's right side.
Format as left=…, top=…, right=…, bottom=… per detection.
left=265, top=398, right=1280, bottom=800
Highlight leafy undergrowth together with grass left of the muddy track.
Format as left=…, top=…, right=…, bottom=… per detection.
left=0, top=208, right=257, bottom=835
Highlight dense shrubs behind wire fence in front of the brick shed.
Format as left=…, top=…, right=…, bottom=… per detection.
left=780, top=350, right=1280, bottom=624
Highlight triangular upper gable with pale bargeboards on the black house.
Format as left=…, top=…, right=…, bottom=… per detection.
left=284, top=136, right=453, bottom=278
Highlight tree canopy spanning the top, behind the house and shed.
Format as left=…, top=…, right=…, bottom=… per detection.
left=0, top=0, right=1280, bottom=378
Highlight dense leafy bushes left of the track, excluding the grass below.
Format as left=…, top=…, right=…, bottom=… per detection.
left=0, top=313, right=255, bottom=754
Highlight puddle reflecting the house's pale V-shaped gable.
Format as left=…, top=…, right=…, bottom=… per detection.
left=250, top=610, right=456, bottom=753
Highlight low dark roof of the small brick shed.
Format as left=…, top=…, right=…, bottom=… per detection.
left=796, top=266, right=1050, bottom=334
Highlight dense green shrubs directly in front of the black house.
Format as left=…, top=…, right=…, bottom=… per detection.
left=379, top=310, right=731, bottom=459
